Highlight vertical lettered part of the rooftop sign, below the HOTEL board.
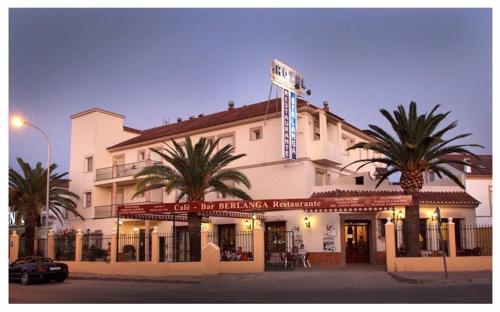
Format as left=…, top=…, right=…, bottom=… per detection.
left=281, top=89, right=297, bottom=160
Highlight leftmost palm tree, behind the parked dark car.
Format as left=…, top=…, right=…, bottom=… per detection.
left=9, top=157, right=83, bottom=255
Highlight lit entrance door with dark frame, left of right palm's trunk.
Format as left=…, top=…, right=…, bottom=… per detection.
left=344, top=221, right=370, bottom=263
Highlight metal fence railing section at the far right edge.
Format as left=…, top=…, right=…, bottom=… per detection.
left=455, top=224, right=493, bottom=257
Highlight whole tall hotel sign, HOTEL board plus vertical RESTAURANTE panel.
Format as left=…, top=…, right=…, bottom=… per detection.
left=270, top=59, right=307, bottom=159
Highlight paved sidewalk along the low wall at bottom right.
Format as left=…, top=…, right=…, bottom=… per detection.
left=389, top=271, right=492, bottom=284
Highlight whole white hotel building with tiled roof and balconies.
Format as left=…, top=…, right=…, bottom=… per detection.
left=68, top=99, right=478, bottom=265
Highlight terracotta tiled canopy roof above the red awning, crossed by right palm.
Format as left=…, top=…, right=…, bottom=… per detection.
left=311, top=190, right=480, bottom=206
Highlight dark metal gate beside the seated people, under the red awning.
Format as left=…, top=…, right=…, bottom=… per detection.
left=264, top=230, right=295, bottom=271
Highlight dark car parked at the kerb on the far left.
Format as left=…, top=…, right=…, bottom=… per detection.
left=9, top=257, right=69, bottom=285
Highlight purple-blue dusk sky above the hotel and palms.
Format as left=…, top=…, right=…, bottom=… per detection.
left=9, top=9, right=492, bottom=171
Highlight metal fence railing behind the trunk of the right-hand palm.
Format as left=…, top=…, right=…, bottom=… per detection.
left=394, top=222, right=448, bottom=257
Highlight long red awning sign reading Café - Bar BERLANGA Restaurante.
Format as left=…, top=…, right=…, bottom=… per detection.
left=118, top=195, right=412, bottom=215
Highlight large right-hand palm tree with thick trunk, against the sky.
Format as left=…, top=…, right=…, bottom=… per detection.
left=342, top=102, right=482, bottom=257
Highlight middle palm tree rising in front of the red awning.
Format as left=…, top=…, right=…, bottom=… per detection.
left=134, top=137, right=250, bottom=261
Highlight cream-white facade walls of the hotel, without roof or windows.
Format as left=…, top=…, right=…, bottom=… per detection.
left=64, top=103, right=479, bottom=262
